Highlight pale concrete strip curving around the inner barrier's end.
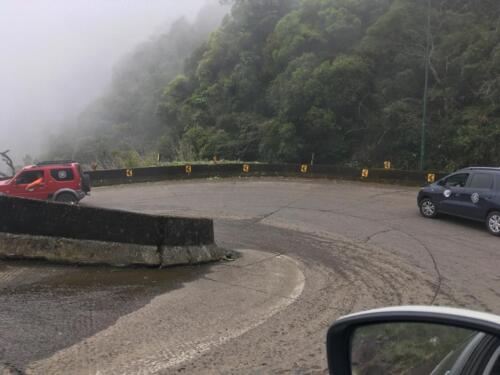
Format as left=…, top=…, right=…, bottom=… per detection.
left=27, top=250, right=305, bottom=374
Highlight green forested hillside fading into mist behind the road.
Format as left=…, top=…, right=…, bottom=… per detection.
left=48, top=0, right=500, bottom=169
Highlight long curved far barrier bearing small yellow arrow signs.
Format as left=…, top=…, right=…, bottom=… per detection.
left=88, top=164, right=446, bottom=186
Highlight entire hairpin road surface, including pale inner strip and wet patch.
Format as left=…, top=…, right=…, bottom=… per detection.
left=0, top=179, right=500, bottom=374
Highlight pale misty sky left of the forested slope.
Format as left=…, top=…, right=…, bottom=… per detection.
left=0, top=0, right=206, bottom=162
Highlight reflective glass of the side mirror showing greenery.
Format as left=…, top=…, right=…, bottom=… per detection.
left=351, top=323, right=500, bottom=375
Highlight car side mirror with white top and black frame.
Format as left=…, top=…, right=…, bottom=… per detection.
left=327, top=307, right=500, bottom=375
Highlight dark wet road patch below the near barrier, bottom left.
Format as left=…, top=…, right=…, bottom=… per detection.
left=0, top=262, right=210, bottom=370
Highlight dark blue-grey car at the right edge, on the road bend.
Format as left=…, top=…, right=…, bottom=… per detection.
left=418, top=167, right=500, bottom=236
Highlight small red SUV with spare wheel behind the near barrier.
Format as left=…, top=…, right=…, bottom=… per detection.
left=0, top=161, right=90, bottom=204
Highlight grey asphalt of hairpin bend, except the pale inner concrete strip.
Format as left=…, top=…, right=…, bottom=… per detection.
left=0, top=179, right=500, bottom=374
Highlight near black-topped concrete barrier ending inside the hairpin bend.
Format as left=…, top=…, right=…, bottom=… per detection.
left=0, top=196, right=226, bottom=267
